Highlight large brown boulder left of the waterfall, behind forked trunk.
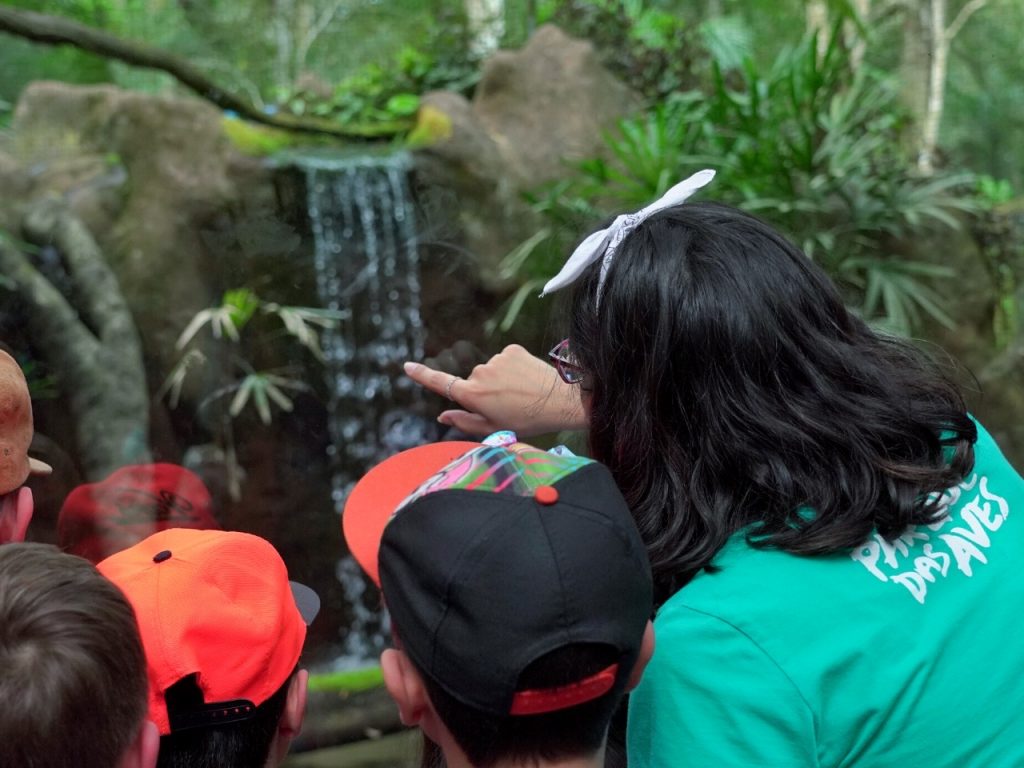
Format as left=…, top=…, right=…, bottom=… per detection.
left=11, top=82, right=251, bottom=370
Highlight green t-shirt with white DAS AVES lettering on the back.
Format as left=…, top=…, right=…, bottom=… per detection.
left=628, top=426, right=1024, bottom=768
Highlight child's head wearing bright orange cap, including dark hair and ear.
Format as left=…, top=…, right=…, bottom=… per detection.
left=97, top=528, right=319, bottom=767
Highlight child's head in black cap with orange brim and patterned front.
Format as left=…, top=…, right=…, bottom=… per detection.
left=344, top=442, right=652, bottom=766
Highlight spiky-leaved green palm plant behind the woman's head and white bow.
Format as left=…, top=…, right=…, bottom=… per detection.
left=501, top=28, right=977, bottom=333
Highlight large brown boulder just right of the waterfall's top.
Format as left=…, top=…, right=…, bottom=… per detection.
left=412, top=26, right=640, bottom=288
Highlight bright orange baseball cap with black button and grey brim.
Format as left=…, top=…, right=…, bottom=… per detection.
left=97, top=528, right=319, bottom=735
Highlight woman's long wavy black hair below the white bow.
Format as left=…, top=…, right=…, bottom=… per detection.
left=569, top=203, right=977, bottom=603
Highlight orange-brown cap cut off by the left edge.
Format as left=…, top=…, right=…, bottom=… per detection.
left=0, top=350, right=52, bottom=494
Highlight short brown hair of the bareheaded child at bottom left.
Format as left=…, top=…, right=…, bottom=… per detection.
left=0, top=544, right=157, bottom=768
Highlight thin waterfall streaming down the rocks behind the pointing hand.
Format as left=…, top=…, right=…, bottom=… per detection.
left=299, top=154, right=434, bottom=666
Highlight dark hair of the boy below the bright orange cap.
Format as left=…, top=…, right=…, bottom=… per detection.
left=157, top=673, right=295, bottom=768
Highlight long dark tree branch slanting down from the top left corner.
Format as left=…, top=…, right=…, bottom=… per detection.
left=0, top=5, right=406, bottom=138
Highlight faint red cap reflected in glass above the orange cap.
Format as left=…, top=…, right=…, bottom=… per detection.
left=57, top=464, right=220, bottom=563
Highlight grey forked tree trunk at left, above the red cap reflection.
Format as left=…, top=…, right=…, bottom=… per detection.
left=0, top=200, right=151, bottom=480
